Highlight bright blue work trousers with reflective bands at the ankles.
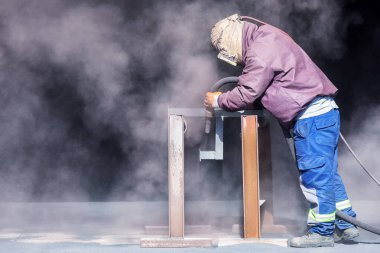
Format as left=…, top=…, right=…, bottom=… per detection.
left=293, top=109, right=356, bottom=236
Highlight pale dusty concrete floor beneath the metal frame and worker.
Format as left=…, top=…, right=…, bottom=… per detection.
left=0, top=202, right=380, bottom=253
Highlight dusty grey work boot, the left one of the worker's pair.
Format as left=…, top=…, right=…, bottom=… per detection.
left=288, top=233, right=334, bottom=248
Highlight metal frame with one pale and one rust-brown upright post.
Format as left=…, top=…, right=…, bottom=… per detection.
left=140, top=108, right=263, bottom=248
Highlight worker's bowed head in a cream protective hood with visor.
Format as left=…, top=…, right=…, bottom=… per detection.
left=211, top=14, right=243, bottom=66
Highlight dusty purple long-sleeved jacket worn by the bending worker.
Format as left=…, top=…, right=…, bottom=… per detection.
left=218, top=22, right=337, bottom=127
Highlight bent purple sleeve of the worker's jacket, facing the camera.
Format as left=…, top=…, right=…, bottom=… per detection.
left=218, top=52, right=274, bottom=111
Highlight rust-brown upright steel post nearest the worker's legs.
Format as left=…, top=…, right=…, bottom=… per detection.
left=241, top=115, right=260, bottom=239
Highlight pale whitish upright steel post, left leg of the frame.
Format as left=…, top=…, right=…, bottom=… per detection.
left=168, top=115, right=185, bottom=238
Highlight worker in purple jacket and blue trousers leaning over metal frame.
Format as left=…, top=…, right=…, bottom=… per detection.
left=204, top=14, right=359, bottom=247
